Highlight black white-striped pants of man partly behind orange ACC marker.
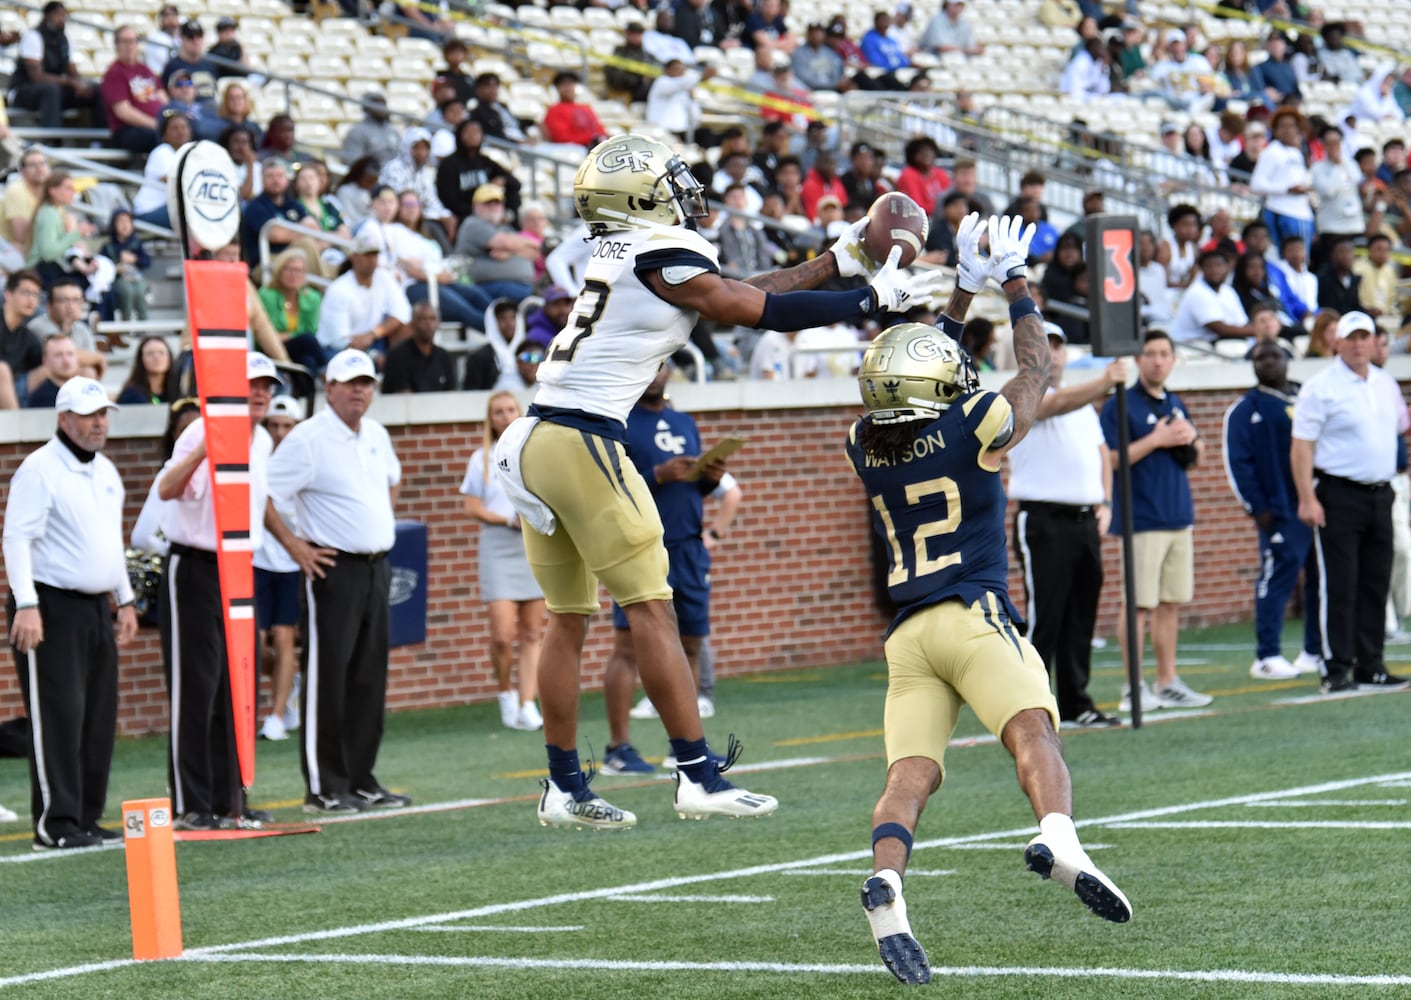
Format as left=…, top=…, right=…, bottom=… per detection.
left=159, top=544, right=244, bottom=817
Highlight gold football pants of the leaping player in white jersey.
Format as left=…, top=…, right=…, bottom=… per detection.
left=521, top=420, right=672, bottom=615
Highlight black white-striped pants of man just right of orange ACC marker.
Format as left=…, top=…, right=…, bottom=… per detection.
left=302, top=553, right=391, bottom=795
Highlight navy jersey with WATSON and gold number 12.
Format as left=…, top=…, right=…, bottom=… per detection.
left=848, top=392, right=1022, bottom=633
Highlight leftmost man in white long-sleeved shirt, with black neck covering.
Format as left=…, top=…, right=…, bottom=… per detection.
left=0, top=377, right=137, bottom=850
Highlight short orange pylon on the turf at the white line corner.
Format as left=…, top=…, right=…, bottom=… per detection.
left=123, top=798, right=182, bottom=962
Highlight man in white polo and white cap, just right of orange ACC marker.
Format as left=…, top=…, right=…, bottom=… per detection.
left=270, top=350, right=412, bottom=814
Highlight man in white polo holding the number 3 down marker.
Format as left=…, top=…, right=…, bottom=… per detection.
left=1009, top=323, right=1127, bottom=728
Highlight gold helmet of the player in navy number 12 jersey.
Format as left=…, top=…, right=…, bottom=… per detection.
left=858, top=323, right=979, bottom=423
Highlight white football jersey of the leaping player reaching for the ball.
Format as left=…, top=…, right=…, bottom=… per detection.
left=535, top=226, right=720, bottom=425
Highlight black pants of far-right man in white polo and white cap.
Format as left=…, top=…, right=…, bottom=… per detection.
left=1314, top=472, right=1395, bottom=680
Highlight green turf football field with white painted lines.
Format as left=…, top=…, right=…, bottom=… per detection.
left=0, top=626, right=1411, bottom=1000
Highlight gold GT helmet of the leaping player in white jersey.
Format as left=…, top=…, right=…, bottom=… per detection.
left=573, top=135, right=706, bottom=236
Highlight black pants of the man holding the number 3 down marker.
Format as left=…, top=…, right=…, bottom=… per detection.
left=1015, top=502, right=1102, bottom=721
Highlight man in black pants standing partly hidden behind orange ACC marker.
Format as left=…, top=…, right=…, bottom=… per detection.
left=157, top=353, right=284, bottom=831
